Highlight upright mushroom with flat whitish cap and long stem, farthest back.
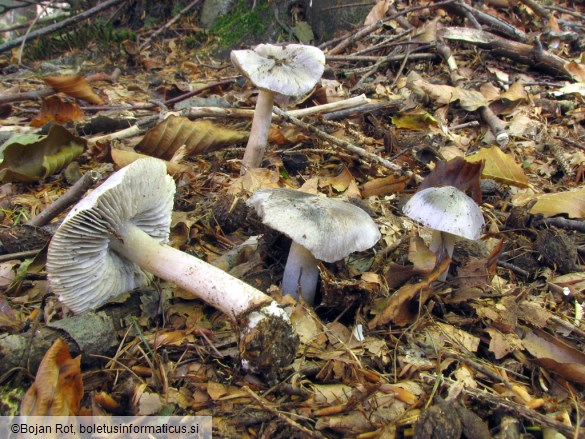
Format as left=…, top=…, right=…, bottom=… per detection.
left=231, top=44, right=325, bottom=175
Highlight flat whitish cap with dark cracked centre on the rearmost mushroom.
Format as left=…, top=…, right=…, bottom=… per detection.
left=231, top=44, right=325, bottom=96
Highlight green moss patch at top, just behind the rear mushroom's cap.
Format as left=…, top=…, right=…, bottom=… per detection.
left=209, top=0, right=270, bottom=47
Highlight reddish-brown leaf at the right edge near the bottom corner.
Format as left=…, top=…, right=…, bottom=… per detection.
left=522, top=329, right=585, bottom=384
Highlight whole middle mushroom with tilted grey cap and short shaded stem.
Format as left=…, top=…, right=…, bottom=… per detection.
left=247, top=189, right=380, bottom=305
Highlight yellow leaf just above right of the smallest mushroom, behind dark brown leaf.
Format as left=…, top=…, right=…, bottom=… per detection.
left=465, top=146, right=528, bottom=188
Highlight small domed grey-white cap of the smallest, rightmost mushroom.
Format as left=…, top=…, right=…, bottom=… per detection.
left=402, top=186, right=484, bottom=239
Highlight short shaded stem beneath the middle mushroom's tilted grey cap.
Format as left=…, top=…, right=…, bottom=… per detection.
left=282, top=241, right=319, bottom=305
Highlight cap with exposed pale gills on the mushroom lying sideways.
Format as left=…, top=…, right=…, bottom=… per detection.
left=47, top=158, right=175, bottom=313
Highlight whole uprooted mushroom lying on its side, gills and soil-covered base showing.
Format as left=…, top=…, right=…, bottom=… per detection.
left=47, top=158, right=298, bottom=371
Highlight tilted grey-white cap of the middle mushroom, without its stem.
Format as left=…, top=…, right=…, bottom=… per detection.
left=246, top=189, right=380, bottom=262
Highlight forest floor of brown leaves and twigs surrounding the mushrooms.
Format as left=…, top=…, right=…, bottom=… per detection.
left=0, top=0, right=585, bottom=439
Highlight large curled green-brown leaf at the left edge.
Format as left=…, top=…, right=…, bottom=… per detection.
left=0, top=125, right=85, bottom=183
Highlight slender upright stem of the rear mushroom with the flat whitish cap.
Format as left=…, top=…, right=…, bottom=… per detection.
left=240, top=89, right=274, bottom=175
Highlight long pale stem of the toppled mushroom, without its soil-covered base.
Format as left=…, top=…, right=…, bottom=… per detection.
left=111, top=222, right=272, bottom=320
